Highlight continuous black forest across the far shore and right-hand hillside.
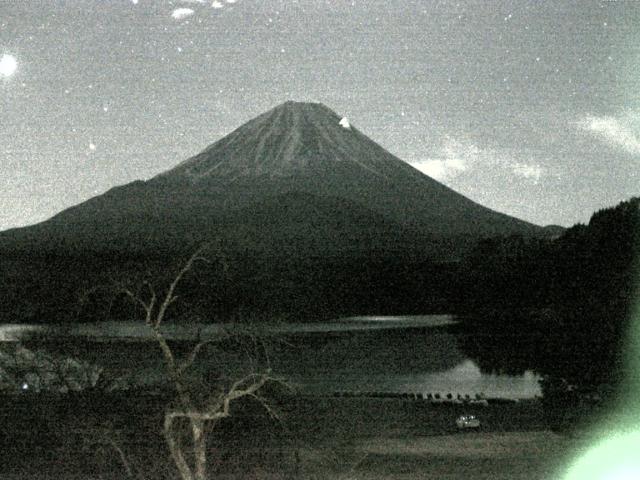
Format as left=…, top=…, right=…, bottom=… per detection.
left=0, top=199, right=638, bottom=340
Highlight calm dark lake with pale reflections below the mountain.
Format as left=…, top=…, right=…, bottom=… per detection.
left=0, top=315, right=540, bottom=399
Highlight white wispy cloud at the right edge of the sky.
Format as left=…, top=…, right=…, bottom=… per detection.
left=577, top=115, right=640, bottom=155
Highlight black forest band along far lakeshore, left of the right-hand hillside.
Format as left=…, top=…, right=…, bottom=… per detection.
left=0, top=246, right=457, bottom=323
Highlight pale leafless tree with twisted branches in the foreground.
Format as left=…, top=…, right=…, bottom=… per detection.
left=120, top=247, right=281, bottom=480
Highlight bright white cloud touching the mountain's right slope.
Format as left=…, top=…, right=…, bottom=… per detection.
left=412, top=136, right=480, bottom=180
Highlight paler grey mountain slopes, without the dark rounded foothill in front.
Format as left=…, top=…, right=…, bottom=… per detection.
left=0, top=102, right=544, bottom=255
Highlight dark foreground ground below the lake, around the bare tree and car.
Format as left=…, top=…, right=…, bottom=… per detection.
left=0, top=395, right=575, bottom=480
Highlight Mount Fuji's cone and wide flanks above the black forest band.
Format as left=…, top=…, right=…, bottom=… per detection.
left=0, top=102, right=544, bottom=254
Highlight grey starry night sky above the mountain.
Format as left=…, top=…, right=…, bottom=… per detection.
left=0, top=0, right=640, bottom=230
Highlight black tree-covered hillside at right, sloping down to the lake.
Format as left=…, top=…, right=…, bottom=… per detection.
left=459, top=198, right=640, bottom=410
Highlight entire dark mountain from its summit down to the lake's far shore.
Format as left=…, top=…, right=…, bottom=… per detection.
left=0, top=102, right=545, bottom=322
